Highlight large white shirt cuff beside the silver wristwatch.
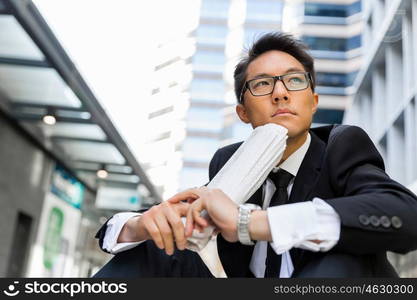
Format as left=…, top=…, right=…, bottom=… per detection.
left=267, top=198, right=341, bottom=254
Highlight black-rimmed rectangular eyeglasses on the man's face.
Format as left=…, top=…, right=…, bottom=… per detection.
left=239, top=72, right=312, bottom=103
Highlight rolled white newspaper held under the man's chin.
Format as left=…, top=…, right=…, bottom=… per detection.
left=187, top=123, right=288, bottom=252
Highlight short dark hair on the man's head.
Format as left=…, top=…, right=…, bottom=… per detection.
left=234, top=32, right=315, bottom=103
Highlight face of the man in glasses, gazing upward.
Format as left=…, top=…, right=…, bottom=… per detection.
left=236, top=50, right=318, bottom=138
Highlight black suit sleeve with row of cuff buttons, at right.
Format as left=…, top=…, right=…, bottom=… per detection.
left=326, top=126, right=417, bottom=254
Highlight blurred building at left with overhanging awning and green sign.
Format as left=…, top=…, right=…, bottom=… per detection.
left=0, top=1, right=161, bottom=277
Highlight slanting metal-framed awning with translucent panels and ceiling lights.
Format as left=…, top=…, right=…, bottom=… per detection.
left=0, top=0, right=161, bottom=203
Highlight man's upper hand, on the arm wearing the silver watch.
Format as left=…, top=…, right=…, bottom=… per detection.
left=168, top=187, right=238, bottom=242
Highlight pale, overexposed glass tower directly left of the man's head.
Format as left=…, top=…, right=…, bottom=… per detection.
left=180, top=0, right=283, bottom=188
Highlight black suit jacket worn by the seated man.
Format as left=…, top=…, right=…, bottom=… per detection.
left=209, top=125, right=417, bottom=277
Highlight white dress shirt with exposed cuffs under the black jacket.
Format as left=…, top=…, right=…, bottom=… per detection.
left=103, top=134, right=341, bottom=278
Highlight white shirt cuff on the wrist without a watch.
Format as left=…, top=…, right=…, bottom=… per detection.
left=103, top=212, right=143, bottom=254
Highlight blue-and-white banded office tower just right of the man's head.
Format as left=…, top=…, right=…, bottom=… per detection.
left=284, top=0, right=363, bottom=124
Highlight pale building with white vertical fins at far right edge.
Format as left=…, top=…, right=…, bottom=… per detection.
left=343, top=0, right=417, bottom=277
